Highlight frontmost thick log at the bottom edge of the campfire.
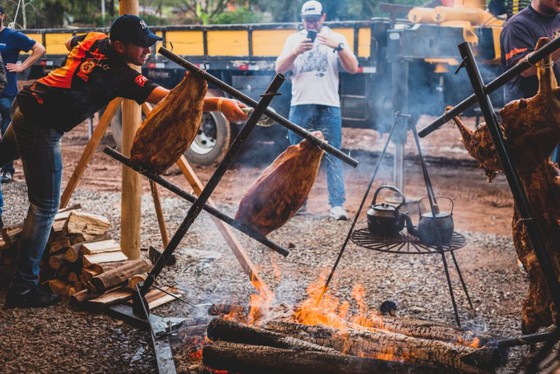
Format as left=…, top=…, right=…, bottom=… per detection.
left=202, top=341, right=434, bottom=374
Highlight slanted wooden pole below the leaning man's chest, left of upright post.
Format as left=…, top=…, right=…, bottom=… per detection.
left=60, top=97, right=122, bottom=208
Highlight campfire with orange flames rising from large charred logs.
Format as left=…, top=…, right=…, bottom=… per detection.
left=179, top=277, right=507, bottom=373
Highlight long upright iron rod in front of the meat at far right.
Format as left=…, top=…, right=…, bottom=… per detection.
left=459, top=39, right=560, bottom=318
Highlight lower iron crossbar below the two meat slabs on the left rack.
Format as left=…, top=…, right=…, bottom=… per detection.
left=103, top=147, right=290, bottom=257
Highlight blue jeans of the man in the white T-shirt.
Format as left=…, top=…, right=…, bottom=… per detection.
left=288, top=105, right=346, bottom=207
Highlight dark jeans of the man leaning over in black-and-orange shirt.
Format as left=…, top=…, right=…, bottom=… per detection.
left=0, top=106, right=62, bottom=289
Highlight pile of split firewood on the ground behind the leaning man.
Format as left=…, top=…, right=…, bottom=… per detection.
left=0, top=205, right=179, bottom=310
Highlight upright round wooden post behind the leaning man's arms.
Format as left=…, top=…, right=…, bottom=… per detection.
left=120, top=0, right=142, bottom=259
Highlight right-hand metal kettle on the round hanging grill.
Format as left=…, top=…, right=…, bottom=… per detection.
left=406, top=197, right=454, bottom=245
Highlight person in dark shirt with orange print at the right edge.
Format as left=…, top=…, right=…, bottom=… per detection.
left=500, top=0, right=560, bottom=162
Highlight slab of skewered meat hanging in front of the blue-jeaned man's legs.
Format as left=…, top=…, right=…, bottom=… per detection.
left=235, top=131, right=324, bottom=235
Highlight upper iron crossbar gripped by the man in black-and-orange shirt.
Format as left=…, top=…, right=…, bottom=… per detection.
left=158, top=47, right=358, bottom=167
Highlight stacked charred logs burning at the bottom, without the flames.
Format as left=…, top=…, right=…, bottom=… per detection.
left=203, top=318, right=507, bottom=374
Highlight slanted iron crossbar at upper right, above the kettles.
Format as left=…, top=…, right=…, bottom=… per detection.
left=418, top=37, right=560, bottom=138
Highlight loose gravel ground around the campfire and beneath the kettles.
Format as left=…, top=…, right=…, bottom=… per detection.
left=0, top=182, right=556, bottom=373
